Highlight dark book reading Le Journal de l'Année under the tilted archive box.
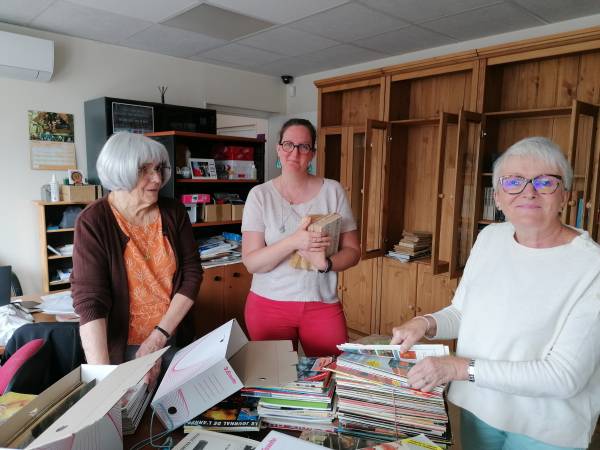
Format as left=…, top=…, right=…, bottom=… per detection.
left=183, top=392, right=260, bottom=433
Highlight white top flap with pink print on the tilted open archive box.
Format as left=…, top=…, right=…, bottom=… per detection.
left=154, top=319, right=248, bottom=398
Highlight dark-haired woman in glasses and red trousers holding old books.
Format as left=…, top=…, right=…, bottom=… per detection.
left=242, top=119, right=360, bottom=356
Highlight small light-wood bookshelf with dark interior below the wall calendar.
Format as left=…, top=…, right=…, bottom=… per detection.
left=34, top=201, right=89, bottom=292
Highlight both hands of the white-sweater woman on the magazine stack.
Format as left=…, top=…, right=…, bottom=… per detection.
left=390, top=317, right=469, bottom=392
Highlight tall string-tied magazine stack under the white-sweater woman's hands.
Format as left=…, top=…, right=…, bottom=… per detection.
left=327, top=344, right=450, bottom=446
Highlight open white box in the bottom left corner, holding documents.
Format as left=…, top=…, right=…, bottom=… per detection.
left=0, top=348, right=167, bottom=450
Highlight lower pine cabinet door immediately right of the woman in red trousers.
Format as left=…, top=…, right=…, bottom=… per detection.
left=340, top=259, right=376, bottom=335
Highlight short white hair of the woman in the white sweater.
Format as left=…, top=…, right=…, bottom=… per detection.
left=492, top=136, right=573, bottom=191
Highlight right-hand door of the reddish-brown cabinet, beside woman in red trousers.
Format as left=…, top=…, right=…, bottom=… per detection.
left=223, top=264, right=252, bottom=335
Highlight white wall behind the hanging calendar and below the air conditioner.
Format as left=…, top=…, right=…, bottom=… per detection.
left=0, top=23, right=284, bottom=293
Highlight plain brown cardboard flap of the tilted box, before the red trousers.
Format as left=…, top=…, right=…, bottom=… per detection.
left=229, top=341, right=298, bottom=387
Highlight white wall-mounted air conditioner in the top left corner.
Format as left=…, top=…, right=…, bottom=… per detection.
left=0, top=31, right=54, bottom=81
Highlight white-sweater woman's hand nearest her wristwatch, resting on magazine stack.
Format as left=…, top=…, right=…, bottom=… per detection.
left=408, top=356, right=469, bottom=392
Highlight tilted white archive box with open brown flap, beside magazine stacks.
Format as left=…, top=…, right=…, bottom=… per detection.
left=152, top=319, right=298, bottom=430
